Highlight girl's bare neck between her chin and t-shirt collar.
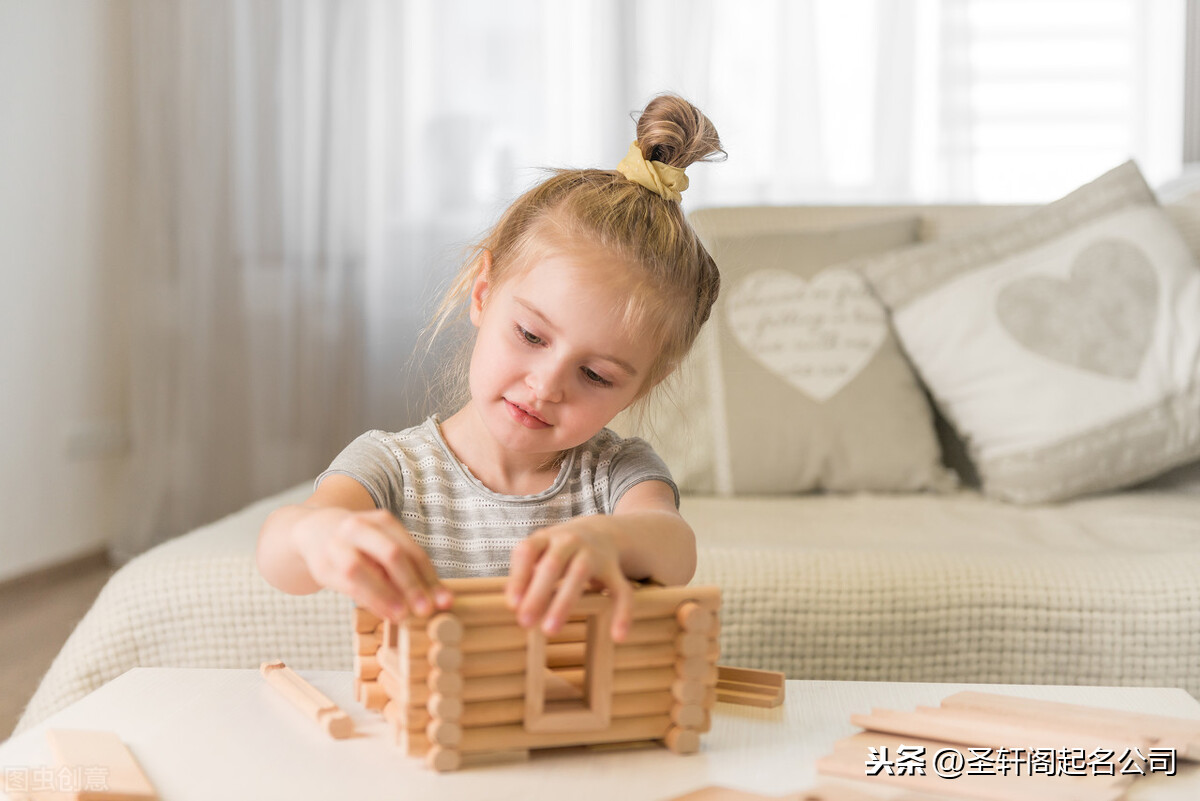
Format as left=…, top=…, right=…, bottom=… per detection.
left=440, top=402, right=562, bottom=495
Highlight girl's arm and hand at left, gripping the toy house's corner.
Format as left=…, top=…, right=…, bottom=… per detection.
left=256, top=475, right=451, bottom=620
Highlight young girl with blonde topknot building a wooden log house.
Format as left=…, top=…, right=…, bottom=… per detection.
left=258, top=95, right=721, bottom=640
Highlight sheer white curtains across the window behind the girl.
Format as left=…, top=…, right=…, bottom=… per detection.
left=116, top=0, right=1182, bottom=555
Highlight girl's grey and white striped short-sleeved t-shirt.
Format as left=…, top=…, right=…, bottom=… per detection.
left=317, top=417, right=679, bottom=578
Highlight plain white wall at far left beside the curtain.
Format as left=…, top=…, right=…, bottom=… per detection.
left=0, top=0, right=133, bottom=579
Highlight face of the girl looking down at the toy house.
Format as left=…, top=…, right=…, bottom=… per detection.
left=470, top=245, right=654, bottom=453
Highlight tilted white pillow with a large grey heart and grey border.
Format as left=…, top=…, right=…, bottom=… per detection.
left=856, top=162, right=1200, bottom=504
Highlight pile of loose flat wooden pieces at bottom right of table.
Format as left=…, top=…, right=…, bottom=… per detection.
left=817, top=692, right=1200, bottom=801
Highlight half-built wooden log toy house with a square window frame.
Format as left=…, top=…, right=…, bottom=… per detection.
left=354, top=578, right=720, bottom=771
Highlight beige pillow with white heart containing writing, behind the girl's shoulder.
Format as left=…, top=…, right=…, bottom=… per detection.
left=613, top=215, right=956, bottom=495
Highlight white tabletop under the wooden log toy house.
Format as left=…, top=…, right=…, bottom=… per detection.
left=0, top=668, right=1200, bottom=801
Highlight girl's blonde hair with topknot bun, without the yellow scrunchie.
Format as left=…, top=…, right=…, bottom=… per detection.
left=427, top=95, right=725, bottom=410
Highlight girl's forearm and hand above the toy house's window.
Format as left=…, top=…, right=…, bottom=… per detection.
left=506, top=481, right=696, bottom=642
